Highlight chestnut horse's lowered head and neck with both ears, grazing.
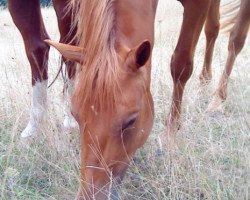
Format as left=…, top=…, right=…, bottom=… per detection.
left=46, top=0, right=158, bottom=200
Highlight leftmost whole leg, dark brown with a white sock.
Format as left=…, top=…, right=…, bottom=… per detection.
left=8, top=0, right=49, bottom=138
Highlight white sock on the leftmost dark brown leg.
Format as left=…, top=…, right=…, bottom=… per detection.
left=21, top=80, right=48, bottom=138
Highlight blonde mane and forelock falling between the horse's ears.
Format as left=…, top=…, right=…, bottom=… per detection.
left=71, top=0, right=120, bottom=109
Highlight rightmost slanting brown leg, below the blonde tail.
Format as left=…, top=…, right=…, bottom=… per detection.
left=206, top=0, right=250, bottom=112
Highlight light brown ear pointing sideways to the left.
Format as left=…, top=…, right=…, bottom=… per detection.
left=44, top=40, right=85, bottom=64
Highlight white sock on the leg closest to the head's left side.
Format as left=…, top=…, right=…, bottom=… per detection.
left=63, top=79, right=77, bottom=130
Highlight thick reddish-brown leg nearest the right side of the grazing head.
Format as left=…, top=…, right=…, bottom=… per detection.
left=161, top=0, right=210, bottom=145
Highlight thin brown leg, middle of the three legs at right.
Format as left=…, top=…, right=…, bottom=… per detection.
left=199, top=0, right=220, bottom=85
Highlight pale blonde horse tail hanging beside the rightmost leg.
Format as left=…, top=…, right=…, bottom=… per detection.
left=220, top=0, right=241, bottom=33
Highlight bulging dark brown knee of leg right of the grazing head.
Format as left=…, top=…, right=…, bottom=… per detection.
left=170, top=53, right=193, bottom=84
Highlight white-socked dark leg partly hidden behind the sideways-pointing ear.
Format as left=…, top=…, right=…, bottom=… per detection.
left=53, top=0, right=77, bottom=130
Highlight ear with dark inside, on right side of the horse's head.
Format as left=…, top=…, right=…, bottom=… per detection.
left=127, top=40, right=151, bottom=71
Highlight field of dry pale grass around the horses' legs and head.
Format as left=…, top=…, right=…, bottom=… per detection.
left=0, top=0, right=250, bottom=200
